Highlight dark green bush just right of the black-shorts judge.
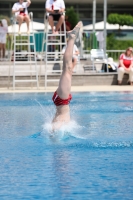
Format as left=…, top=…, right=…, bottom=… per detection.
left=65, top=6, right=79, bottom=28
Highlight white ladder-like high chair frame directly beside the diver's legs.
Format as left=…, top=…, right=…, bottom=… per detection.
left=42, top=12, right=66, bottom=88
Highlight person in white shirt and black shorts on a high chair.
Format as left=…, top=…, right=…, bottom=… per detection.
left=45, top=0, right=65, bottom=34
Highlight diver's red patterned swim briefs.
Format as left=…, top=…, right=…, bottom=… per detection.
left=52, top=91, right=72, bottom=106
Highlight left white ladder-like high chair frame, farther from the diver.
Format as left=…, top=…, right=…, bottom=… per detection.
left=11, top=12, right=39, bottom=89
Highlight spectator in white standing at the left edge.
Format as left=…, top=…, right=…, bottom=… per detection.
left=0, top=19, right=8, bottom=60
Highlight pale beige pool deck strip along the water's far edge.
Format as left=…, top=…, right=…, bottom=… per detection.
left=0, top=85, right=133, bottom=93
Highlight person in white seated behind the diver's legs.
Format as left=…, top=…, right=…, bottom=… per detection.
left=62, top=39, right=79, bottom=69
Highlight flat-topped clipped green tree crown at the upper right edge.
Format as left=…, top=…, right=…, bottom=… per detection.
left=107, top=13, right=133, bottom=26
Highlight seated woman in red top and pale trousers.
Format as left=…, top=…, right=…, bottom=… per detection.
left=118, top=47, right=133, bottom=85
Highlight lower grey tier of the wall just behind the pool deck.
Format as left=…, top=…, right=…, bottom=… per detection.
left=0, top=73, right=128, bottom=88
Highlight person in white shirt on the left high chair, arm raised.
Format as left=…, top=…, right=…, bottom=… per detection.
left=12, top=0, right=31, bottom=34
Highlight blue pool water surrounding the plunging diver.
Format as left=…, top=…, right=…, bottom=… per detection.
left=0, top=92, right=133, bottom=200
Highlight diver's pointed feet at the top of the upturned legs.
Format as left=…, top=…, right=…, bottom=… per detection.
left=67, top=21, right=82, bottom=39
